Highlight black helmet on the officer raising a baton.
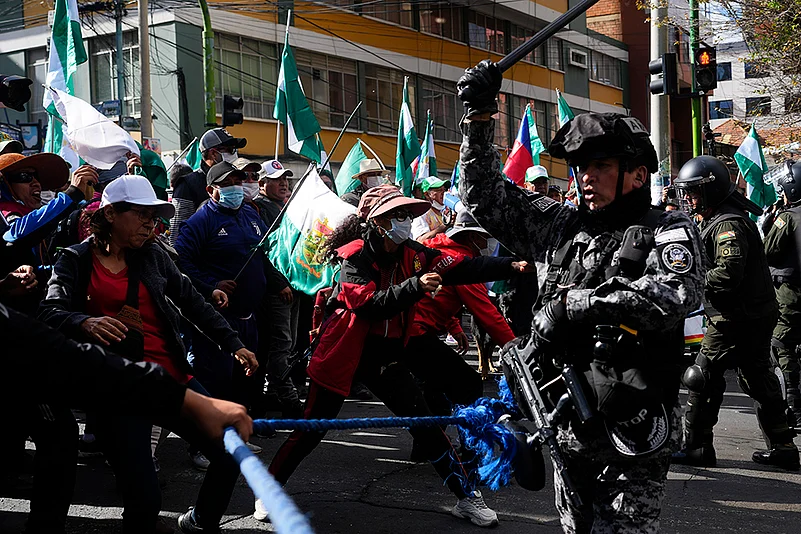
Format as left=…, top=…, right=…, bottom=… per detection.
left=548, top=113, right=659, bottom=174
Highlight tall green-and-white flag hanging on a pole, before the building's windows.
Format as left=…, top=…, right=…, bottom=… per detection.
left=273, top=28, right=322, bottom=163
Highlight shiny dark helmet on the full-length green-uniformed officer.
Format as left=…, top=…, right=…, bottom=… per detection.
left=673, top=156, right=762, bottom=215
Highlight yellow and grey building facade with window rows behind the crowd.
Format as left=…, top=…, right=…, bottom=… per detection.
left=0, top=0, right=630, bottom=179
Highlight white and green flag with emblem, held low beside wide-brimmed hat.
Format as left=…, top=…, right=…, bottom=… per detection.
left=267, top=169, right=356, bottom=295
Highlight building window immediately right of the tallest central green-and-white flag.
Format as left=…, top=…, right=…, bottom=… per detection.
left=294, top=49, right=359, bottom=128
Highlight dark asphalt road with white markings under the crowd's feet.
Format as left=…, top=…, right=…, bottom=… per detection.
left=0, top=362, right=801, bottom=534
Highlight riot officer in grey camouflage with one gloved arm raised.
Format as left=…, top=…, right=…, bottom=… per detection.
left=457, top=61, right=703, bottom=532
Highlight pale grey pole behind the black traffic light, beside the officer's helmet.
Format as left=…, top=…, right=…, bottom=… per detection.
left=651, top=0, right=671, bottom=205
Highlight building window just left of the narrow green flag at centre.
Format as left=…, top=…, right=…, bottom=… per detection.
left=364, top=63, right=415, bottom=134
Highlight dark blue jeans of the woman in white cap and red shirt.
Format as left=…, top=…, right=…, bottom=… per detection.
left=98, top=379, right=239, bottom=534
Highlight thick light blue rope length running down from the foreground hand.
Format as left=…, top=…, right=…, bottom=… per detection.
left=223, top=428, right=314, bottom=534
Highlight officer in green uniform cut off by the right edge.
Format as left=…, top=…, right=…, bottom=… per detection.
left=765, top=161, right=801, bottom=429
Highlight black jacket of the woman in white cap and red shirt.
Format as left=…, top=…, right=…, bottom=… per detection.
left=39, top=240, right=244, bottom=367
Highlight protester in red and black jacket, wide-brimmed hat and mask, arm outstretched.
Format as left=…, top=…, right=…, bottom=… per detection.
left=262, top=185, right=528, bottom=526
